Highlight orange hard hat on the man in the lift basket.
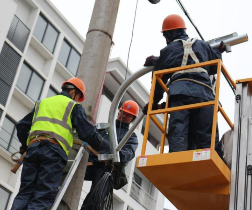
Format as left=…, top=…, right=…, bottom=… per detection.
left=161, top=14, right=186, bottom=32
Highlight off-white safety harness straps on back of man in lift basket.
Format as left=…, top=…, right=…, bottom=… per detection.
left=171, top=38, right=207, bottom=78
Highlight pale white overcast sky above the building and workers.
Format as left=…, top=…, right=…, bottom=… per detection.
left=51, top=0, right=252, bottom=210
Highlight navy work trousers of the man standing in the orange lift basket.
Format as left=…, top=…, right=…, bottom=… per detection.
left=168, top=95, right=221, bottom=155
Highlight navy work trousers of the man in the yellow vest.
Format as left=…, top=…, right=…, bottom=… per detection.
left=11, top=141, right=66, bottom=210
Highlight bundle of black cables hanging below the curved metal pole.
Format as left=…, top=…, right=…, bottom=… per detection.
left=91, top=172, right=113, bottom=210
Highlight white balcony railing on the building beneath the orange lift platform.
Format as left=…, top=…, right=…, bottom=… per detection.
left=130, top=181, right=156, bottom=210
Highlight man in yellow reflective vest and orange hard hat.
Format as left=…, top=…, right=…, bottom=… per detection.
left=11, top=78, right=102, bottom=210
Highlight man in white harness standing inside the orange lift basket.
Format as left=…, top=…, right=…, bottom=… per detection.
left=143, top=14, right=225, bottom=156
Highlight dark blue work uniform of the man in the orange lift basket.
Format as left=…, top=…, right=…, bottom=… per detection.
left=153, top=31, right=221, bottom=153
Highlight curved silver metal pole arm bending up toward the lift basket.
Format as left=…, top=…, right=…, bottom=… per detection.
left=109, top=66, right=153, bottom=162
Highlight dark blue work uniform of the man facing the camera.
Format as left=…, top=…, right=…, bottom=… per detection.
left=81, top=120, right=138, bottom=210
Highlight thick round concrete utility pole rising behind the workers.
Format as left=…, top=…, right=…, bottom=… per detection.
left=63, top=0, right=120, bottom=210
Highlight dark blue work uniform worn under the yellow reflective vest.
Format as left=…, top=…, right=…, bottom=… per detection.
left=11, top=91, right=102, bottom=210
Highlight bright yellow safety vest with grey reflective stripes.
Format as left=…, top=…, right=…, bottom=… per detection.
left=27, top=95, right=77, bottom=155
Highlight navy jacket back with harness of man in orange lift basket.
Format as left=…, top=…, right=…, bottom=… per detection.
left=153, top=31, right=221, bottom=101
